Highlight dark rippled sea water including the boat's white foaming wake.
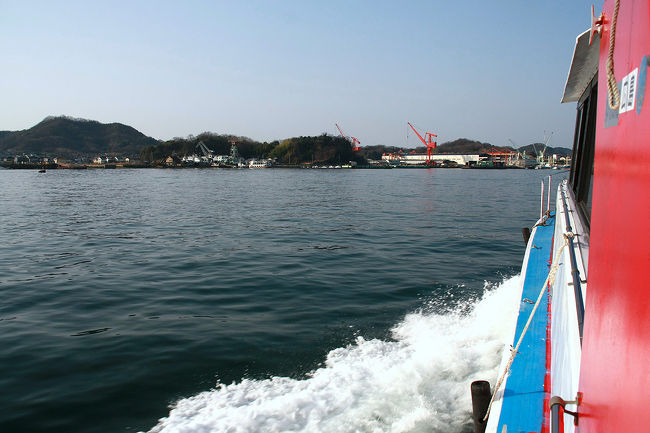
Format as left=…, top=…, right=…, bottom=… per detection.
left=0, top=169, right=549, bottom=432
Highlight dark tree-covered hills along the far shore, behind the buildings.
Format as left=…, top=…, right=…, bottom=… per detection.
left=0, top=116, right=571, bottom=166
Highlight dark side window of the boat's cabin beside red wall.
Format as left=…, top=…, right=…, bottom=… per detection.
left=570, top=78, right=598, bottom=227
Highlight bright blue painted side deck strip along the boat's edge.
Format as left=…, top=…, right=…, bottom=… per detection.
left=497, top=213, right=555, bottom=433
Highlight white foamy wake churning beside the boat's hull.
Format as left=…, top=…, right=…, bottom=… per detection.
left=151, top=276, right=519, bottom=433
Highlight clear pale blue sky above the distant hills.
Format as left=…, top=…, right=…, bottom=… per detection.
left=0, top=0, right=602, bottom=147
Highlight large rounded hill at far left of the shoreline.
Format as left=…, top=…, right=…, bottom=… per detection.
left=0, top=116, right=158, bottom=158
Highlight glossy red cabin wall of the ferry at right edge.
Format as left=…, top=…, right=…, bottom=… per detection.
left=576, top=0, right=650, bottom=433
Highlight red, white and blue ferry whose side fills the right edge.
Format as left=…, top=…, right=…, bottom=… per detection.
left=471, top=0, right=650, bottom=433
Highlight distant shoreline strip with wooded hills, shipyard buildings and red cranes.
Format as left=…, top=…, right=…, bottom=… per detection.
left=0, top=120, right=571, bottom=169
